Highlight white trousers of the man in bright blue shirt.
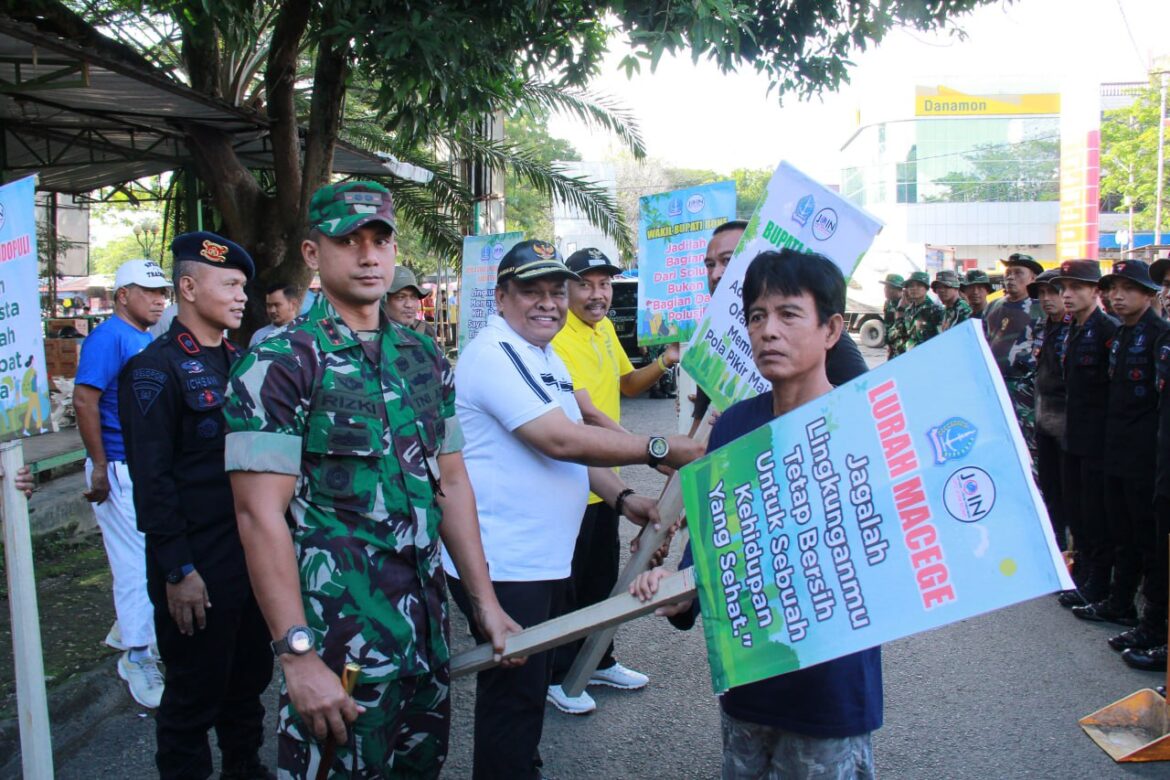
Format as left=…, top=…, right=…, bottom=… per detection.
left=85, top=458, right=154, bottom=648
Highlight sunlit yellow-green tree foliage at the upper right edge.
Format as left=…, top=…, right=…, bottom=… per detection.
left=1101, top=82, right=1170, bottom=232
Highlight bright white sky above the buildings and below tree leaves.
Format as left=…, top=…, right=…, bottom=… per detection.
left=550, top=0, right=1170, bottom=184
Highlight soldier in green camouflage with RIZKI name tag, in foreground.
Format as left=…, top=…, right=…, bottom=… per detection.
left=225, top=182, right=518, bottom=778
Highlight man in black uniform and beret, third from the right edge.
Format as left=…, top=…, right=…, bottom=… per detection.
left=1057, top=260, right=1117, bottom=607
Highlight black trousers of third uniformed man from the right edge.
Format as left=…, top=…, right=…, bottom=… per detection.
left=1062, top=453, right=1113, bottom=591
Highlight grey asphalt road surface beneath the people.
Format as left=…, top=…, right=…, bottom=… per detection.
left=41, top=390, right=1170, bottom=780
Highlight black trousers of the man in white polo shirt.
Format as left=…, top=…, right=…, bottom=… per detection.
left=447, top=577, right=569, bottom=780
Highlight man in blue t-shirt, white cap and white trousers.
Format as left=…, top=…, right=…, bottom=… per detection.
left=74, top=260, right=170, bottom=707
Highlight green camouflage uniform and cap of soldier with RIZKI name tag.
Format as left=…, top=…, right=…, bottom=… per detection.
left=223, top=182, right=463, bottom=778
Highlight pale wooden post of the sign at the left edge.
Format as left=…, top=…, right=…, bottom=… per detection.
left=0, top=441, right=53, bottom=780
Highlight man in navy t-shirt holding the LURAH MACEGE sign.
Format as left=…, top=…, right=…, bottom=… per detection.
left=629, top=249, right=882, bottom=780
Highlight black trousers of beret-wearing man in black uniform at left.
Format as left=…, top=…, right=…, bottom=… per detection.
left=150, top=581, right=273, bottom=780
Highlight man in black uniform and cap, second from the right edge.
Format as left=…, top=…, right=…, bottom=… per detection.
left=1073, top=260, right=1170, bottom=626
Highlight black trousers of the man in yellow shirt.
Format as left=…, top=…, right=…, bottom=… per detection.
left=552, top=502, right=621, bottom=685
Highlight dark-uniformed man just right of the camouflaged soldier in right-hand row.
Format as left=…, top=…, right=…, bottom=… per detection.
left=1027, top=269, right=1072, bottom=550
